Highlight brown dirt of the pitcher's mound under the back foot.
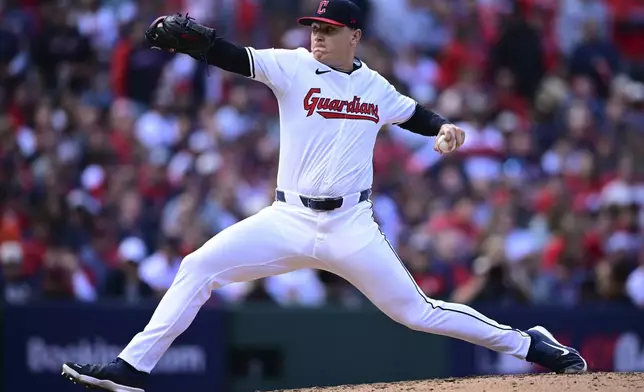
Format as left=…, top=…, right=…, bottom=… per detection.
left=275, top=373, right=644, bottom=392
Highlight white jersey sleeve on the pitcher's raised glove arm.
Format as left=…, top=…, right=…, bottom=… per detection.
left=246, top=47, right=301, bottom=95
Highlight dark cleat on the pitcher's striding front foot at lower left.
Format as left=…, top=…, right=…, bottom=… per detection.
left=62, top=358, right=149, bottom=392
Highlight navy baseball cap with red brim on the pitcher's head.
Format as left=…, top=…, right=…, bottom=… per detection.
left=297, top=0, right=364, bottom=29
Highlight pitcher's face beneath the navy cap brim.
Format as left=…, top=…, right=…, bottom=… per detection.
left=311, top=22, right=361, bottom=65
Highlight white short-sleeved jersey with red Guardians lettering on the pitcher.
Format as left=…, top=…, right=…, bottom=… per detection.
left=246, top=47, right=416, bottom=197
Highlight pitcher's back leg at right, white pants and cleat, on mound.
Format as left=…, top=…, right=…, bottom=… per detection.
left=324, top=204, right=585, bottom=370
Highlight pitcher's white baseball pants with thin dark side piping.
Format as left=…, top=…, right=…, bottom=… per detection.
left=119, top=192, right=530, bottom=372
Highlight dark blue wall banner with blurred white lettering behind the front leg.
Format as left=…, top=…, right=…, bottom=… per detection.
left=3, top=304, right=226, bottom=392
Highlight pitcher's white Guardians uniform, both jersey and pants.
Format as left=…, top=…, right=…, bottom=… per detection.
left=119, top=48, right=530, bottom=372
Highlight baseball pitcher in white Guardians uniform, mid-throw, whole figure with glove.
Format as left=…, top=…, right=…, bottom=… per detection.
left=62, top=0, right=587, bottom=392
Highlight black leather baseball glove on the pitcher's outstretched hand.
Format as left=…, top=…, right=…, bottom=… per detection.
left=145, top=14, right=217, bottom=58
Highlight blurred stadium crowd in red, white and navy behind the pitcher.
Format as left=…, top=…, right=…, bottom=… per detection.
left=0, top=0, right=644, bottom=308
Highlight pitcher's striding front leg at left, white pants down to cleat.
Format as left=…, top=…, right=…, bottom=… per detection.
left=64, top=203, right=315, bottom=392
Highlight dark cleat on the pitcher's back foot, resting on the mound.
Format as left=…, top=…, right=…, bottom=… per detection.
left=526, top=326, right=588, bottom=373
